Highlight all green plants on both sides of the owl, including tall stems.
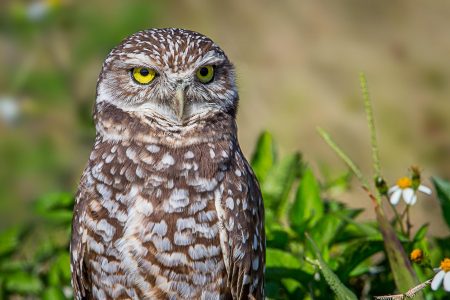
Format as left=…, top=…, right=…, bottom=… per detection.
left=0, top=78, right=450, bottom=299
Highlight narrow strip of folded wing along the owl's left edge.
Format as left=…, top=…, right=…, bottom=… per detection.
left=70, top=176, right=92, bottom=300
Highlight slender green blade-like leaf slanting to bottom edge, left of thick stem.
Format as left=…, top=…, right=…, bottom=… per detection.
left=306, top=234, right=358, bottom=300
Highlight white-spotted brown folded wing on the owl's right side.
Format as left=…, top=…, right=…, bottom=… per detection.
left=215, top=150, right=265, bottom=299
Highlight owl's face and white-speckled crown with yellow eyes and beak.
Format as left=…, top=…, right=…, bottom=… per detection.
left=97, top=29, right=238, bottom=125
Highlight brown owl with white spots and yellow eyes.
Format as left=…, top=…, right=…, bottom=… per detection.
left=71, top=28, right=265, bottom=299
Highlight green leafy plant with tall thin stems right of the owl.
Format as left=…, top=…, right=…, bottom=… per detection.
left=252, top=75, right=450, bottom=299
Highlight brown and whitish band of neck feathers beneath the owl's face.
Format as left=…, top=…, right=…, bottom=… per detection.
left=94, top=103, right=237, bottom=147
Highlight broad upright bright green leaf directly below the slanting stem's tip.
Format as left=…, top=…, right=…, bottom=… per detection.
left=289, top=168, right=324, bottom=227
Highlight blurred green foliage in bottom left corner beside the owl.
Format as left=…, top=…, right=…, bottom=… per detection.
left=0, top=193, right=73, bottom=300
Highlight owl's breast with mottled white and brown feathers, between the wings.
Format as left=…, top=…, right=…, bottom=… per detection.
left=84, top=135, right=234, bottom=299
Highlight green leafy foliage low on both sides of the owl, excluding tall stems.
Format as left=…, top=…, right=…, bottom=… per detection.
left=0, top=139, right=450, bottom=299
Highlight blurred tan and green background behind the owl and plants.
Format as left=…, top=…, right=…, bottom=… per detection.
left=0, top=0, right=450, bottom=235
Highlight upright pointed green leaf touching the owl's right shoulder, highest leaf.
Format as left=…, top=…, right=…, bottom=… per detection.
left=251, top=131, right=276, bottom=183
